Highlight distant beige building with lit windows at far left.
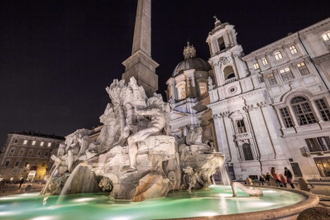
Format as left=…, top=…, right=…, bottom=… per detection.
left=0, top=132, right=64, bottom=181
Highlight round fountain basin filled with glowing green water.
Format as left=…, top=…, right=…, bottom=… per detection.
left=0, top=186, right=318, bottom=220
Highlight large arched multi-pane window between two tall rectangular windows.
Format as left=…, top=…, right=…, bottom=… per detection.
left=291, top=96, right=316, bottom=125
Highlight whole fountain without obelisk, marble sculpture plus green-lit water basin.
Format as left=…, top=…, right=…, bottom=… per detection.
left=0, top=78, right=318, bottom=220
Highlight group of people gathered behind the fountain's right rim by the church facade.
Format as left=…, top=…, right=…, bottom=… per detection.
left=259, top=167, right=295, bottom=189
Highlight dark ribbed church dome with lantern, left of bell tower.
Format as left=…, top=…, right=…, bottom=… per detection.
left=172, top=42, right=212, bottom=77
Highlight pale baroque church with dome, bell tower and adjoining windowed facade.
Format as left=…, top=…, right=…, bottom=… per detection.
left=167, top=18, right=330, bottom=180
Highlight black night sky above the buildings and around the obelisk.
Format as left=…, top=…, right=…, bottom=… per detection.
left=0, top=0, right=330, bottom=147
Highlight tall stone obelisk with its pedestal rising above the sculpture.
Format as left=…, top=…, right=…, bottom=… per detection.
left=122, top=0, right=159, bottom=97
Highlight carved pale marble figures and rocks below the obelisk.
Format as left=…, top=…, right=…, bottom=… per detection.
left=47, top=77, right=229, bottom=202
